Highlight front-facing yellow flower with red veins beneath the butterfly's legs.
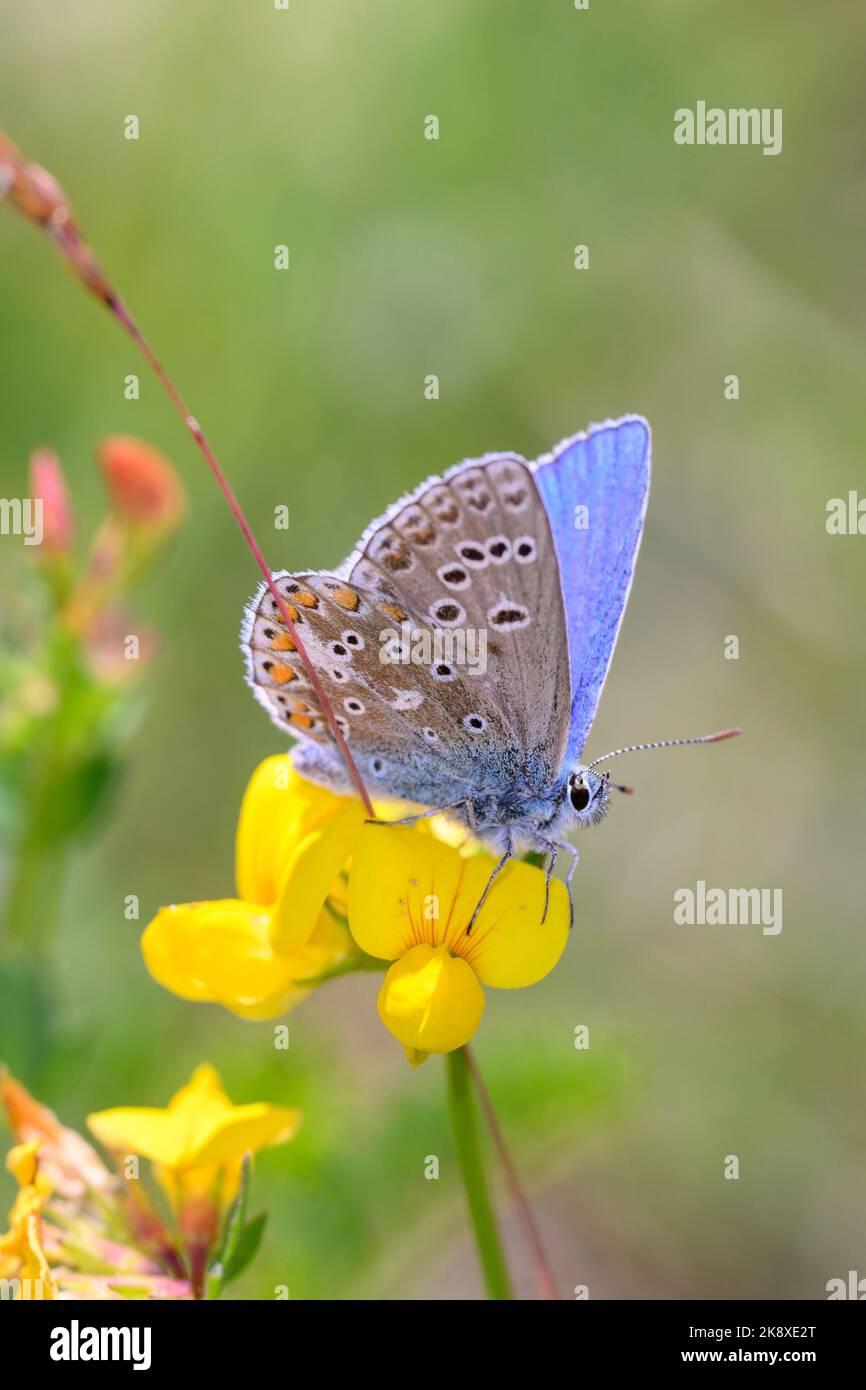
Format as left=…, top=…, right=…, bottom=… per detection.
left=349, top=826, right=569, bottom=1065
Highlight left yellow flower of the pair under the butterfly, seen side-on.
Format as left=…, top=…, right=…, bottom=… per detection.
left=142, top=755, right=364, bottom=1019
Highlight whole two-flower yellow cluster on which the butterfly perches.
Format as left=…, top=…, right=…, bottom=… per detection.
left=142, top=756, right=569, bottom=1063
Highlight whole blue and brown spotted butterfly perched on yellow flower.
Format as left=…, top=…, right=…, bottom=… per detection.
left=240, top=416, right=733, bottom=912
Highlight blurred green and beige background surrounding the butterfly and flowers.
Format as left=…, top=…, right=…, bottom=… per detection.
left=0, top=0, right=866, bottom=1298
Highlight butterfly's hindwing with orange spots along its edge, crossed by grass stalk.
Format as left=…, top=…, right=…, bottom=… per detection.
left=242, top=573, right=528, bottom=805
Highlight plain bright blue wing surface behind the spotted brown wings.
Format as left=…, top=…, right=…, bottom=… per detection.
left=532, top=416, right=651, bottom=765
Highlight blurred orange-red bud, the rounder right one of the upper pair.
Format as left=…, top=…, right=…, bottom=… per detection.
left=99, top=435, right=186, bottom=532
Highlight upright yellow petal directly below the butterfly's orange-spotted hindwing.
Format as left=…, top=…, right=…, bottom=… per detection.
left=238, top=756, right=364, bottom=954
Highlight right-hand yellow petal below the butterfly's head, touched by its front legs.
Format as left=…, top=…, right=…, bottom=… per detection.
left=463, top=862, right=570, bottom=990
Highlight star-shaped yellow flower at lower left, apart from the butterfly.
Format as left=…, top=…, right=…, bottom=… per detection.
left=88, top=1065, right=300, bottom=1207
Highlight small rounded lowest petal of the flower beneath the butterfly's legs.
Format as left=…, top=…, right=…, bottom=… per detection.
left=379, top=945, right=484, bottom=1065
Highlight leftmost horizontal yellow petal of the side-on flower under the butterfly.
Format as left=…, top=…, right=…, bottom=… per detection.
left=142, top=898, right=308, bottom=1019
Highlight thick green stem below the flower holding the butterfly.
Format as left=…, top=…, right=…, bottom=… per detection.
left=446, top=1048, right=512, bottom=1300
